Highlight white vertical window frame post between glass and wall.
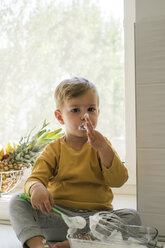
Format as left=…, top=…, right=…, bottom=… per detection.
left=124, top=0, right=136, bottom=189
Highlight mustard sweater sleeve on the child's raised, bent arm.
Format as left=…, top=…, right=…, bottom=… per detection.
left=101, top=138, right=128, bottom=187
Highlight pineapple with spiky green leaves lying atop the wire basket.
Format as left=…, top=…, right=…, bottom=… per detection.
left=0, top=121, right=63, bottom=172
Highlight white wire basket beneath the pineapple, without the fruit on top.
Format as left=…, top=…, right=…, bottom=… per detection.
left=0, top=169, right=24, bottom=194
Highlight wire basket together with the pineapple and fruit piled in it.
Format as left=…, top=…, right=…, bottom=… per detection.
left=0, top=121, right=64, bottom=195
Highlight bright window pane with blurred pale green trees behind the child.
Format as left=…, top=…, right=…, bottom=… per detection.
left=0, top=0, right=125, bottom=161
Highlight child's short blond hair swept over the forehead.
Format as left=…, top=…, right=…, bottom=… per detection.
left=54, top=77, right=99, bottom=109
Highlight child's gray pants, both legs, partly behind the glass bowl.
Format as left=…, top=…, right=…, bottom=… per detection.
left=9, top=195, right=141, bottom=245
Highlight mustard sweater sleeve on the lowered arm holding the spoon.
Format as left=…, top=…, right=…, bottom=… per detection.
left=24, top=142, right=58, bottom=195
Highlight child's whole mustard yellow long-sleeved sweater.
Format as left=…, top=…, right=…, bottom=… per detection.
left=24, top=138, right=128, bottom=210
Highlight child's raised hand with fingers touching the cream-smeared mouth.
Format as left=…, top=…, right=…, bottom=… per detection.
left=85, top=115, right=107, bottom=151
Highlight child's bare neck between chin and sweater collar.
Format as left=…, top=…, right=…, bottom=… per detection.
left=64, top=135, right=87, bottom=151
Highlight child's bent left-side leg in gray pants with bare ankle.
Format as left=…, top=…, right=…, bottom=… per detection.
left=9, top=195, right=67, bottom=248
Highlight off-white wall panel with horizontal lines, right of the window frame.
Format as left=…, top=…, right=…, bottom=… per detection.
left=134, top=0, right=165, bottom=235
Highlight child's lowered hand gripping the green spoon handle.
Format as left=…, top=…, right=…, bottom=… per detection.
left=30, top=183, right=54, bottom=213
